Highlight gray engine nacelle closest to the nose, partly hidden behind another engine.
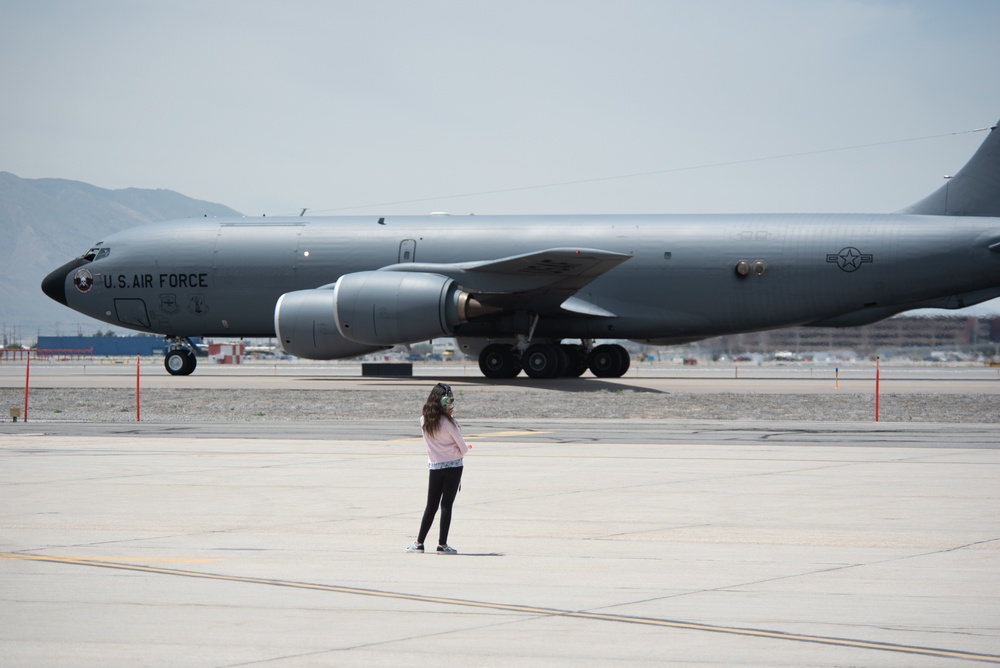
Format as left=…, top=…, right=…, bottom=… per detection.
left=274, top=286, right=386, bottom=360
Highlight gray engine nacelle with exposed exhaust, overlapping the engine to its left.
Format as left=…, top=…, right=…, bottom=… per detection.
left=333, top=271, right=466, bottom=346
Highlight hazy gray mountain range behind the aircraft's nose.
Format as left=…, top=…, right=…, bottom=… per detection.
left=0, top=172, right=241, bottom=345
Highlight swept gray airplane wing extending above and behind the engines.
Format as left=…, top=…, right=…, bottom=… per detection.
left=383, top=248, right=632, bottom=317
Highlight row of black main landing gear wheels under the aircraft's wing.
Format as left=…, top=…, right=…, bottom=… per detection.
left=479, top=343, right=630, bottom=379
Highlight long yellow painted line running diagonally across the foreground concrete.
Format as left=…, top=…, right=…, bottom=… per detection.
left=0, top=553, right=1000, bottom=664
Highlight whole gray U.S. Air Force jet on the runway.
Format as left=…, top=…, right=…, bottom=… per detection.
left=42, top=118, right=1000, bottom=379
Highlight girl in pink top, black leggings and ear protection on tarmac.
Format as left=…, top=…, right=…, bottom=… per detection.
left=406, top=383, right=472, bottom=554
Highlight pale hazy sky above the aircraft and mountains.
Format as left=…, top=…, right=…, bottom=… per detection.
left=0, top=0, right=1000, bottom=215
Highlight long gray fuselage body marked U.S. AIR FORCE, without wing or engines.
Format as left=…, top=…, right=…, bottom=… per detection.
left=37, top=214, right=1000, bottom=342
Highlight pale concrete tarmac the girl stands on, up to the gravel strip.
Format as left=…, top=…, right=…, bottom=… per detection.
left=0, top=412, right=1000, bottom=668
